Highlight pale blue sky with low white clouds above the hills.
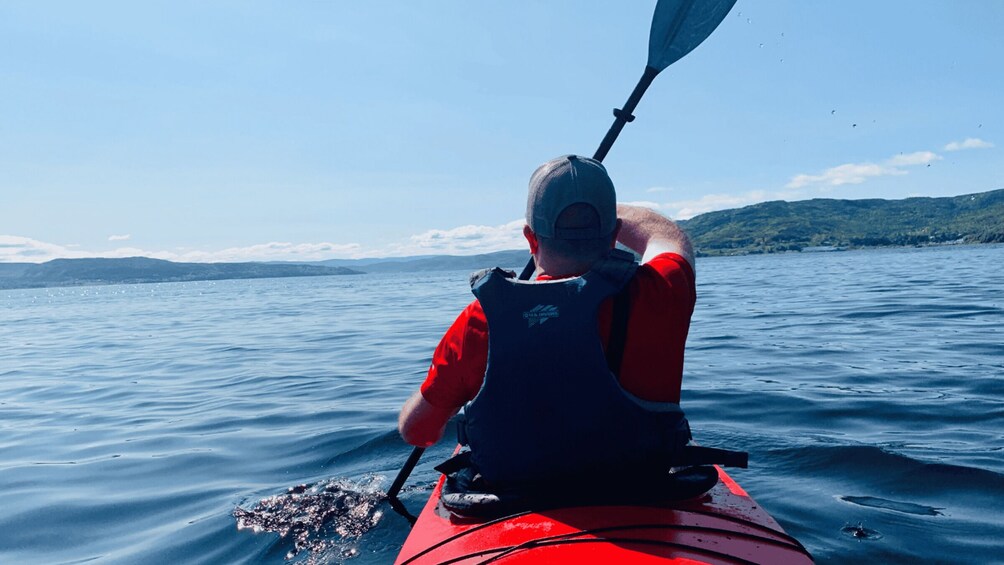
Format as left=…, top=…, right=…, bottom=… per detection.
left=0, top=0, right=1004, bottom=262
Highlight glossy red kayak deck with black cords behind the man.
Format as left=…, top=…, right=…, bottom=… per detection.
left=396, top=468, right=812, bottom=565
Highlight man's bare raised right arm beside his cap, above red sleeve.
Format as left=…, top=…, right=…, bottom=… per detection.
left=617, top=204, right=695, bottom=268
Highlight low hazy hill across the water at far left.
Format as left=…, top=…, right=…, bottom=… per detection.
left=0, top=257, right=360, bottom=288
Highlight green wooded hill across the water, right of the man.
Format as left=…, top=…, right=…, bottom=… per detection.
left=680, top=189, right=1004, bottom=255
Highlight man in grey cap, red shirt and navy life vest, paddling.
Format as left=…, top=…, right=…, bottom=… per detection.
left=399, top=156, right=696, bottom=491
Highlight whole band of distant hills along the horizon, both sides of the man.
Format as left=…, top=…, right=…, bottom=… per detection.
left=0, top=189, right=1004, bottom=289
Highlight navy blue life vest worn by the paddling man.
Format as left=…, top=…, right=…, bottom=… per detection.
left=461, top=250, right=691, bottom=489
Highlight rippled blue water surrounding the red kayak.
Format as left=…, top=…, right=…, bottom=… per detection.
left=0, top=246, right=1004, bottom=564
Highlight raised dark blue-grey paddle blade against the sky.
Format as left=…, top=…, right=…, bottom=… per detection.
left=649, top=0, right=736, bottom=70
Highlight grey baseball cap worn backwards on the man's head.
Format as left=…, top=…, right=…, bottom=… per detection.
left=526, top=155, right=617, bottom=239
